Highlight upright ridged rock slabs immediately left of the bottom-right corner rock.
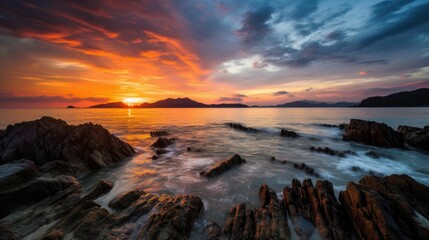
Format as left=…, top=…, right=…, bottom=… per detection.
left=283, top=179, right=351, bottom=239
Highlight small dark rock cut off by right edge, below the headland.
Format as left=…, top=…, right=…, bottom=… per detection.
left=398, top=126, right=429, bottom=151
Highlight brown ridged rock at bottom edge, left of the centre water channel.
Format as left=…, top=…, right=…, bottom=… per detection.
left=137, top=195, right=204, bottom=239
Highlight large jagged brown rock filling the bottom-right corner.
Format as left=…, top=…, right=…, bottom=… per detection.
left=339, top=175, right=429, bottom=239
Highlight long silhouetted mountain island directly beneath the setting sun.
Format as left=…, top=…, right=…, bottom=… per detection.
left=90, top=98, right=249, bottom=108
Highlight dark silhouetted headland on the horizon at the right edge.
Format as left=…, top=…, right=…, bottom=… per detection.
left=359, top=88, right=429, bottom=107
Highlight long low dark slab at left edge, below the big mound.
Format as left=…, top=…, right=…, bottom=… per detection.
left=0, top=176, right=80, bottom=218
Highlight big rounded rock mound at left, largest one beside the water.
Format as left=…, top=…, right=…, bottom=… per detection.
left=0, top=117, right=134, bottom=174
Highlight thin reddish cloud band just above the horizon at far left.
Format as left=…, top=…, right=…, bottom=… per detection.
left=0, top=94, right=109, bottom=103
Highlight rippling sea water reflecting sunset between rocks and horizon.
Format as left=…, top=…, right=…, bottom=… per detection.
left=0, top=108, right=429, bottom=239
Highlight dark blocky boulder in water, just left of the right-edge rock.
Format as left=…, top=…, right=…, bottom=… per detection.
left=343, top=119, right=405, bottom=148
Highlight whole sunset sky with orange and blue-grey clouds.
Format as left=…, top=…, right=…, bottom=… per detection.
left=0, top=0, right=429, bottom=107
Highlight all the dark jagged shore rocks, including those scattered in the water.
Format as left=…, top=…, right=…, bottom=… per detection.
left=0, top=117, right=429, bottom=240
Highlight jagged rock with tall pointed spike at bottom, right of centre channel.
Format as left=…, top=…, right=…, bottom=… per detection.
left=223, top=184, right=290, bottom=239
